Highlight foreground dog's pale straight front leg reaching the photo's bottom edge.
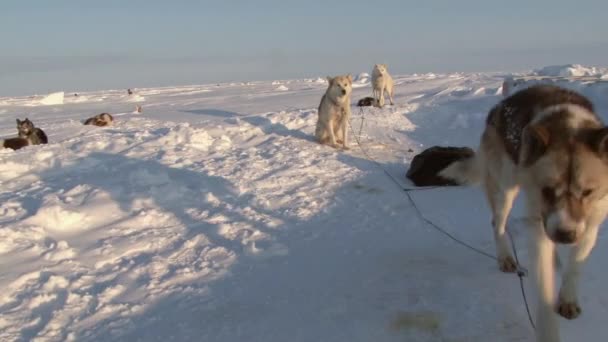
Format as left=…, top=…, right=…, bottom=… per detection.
left=530, top=220, right=560, bottom=342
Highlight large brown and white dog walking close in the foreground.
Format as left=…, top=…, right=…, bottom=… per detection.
left=440, top=85, right=608, bottom=342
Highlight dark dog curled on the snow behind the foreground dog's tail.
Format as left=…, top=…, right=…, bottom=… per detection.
left=406, top=146, right=475, bottom=186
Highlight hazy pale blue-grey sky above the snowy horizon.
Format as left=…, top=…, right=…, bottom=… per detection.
left=0, top=0, right=608, bottom=97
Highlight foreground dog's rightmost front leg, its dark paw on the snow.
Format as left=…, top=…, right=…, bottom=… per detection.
left=557, top=225, right=599, bottom=319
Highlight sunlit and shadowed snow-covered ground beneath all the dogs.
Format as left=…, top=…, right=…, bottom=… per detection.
left=0, top=65, right=608, bottom=342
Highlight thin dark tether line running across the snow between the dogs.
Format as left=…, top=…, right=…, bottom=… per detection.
left=348, top=107, right=536, bottom=330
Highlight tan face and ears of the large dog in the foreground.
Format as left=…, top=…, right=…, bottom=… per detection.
left=527, top=124, right=608, bottom=244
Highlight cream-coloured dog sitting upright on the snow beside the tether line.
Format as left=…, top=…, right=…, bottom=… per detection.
left=315, top=75, right=353, bottom=149
